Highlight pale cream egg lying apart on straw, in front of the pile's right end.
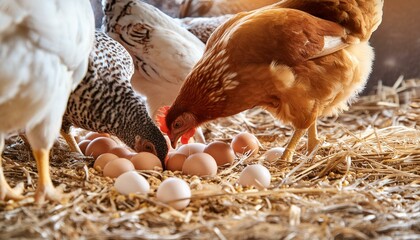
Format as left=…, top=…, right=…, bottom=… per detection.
left=238, top=164, right=271, bottom=189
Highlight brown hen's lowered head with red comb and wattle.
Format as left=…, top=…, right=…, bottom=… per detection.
left=157, top=106, right=198, bottom=148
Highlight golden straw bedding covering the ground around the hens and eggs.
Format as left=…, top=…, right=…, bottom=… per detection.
left=0, top=79, right=420, bottom=239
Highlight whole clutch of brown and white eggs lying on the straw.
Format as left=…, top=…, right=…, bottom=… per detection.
left=79, top=132, right=284, bottom=210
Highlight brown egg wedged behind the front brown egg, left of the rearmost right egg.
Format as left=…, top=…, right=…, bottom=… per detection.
left=204, top=141, right=235, bottom=166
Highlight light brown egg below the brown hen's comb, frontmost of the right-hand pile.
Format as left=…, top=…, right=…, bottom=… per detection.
left=182, top=153, right=217, bottom=176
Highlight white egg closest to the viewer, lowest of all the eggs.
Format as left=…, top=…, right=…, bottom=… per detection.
left=156, top=177, right=191, bottom=210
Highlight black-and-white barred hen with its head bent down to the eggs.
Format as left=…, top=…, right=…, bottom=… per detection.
left=63, top=31, right=168, bottom=166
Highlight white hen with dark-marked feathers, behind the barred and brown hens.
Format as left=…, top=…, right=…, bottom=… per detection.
left=103, top=0, right=205, bottom=142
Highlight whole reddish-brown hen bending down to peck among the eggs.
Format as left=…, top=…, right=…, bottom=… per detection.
left=161, top=0, right=383, bottom=160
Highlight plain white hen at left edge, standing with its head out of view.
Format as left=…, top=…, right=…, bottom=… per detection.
left=0, top=0, right=94, bottom=202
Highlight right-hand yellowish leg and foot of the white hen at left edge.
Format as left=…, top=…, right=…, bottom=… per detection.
left=32, top=149, right=62, bottom=203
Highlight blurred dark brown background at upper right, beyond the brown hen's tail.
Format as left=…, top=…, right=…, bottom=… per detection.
left=370, top=0, right=420, bottom=94
